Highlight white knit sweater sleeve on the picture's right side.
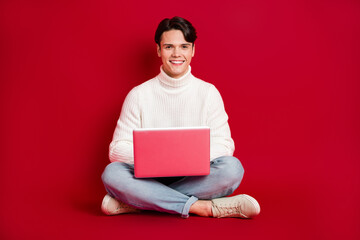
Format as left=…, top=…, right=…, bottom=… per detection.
left=207, top=86, right=235, bottom=160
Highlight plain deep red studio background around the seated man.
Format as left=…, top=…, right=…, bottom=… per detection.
left=0, top=0, right=360, bottom=239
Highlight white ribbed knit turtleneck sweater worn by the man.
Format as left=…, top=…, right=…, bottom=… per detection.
left=109, top=66, right=235, bottom=164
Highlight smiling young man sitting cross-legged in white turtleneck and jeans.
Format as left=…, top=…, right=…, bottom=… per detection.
left=101, top=17, right=260, bottom=218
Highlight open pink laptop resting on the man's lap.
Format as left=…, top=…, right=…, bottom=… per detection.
left=133, top=127, right=210, bottom=178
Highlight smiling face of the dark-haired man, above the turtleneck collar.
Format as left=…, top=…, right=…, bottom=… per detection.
left=157, top=30, right=195, bottom=78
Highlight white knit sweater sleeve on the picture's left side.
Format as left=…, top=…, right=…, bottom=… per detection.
left=109, top=87, right=141, bottom=164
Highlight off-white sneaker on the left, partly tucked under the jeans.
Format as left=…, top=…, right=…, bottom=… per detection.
left=101, top=194, right=140, bottom=215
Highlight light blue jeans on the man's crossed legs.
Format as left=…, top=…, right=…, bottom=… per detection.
left=102, top=156, right=244, bottom=218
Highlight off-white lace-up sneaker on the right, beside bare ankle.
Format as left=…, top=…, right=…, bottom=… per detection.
left=211, top=194, right=260, bottom=218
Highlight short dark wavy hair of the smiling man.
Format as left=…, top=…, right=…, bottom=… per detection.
left=155, top=17, right=197, bottom=46
